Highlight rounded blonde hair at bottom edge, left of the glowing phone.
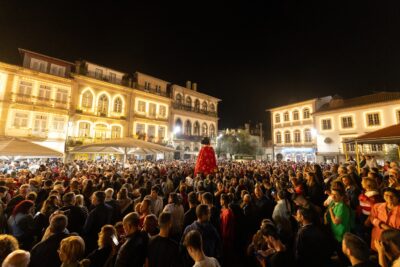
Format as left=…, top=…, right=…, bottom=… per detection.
left=60, top=236, right=85, bottom=263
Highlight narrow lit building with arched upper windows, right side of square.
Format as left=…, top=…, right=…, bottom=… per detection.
left=267, top=96, right=331, bottom=161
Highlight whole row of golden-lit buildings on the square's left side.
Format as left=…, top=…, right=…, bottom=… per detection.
left=0, top=49, right=220, bottom=158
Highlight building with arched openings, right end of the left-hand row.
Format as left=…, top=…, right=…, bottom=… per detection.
left=171, top=81, right=221, bottom=159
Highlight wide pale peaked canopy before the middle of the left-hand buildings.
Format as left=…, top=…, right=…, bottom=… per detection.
left=70, top=138, right=175, bottom=154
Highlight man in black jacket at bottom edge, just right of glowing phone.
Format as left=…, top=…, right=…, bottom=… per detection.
left=115, top=212, right=149, bottom=267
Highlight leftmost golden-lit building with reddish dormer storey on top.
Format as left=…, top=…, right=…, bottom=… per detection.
left=0, top=49, right=74, bottom=152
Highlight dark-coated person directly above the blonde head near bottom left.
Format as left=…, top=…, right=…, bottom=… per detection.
left=60, top=192, right=87, bottom=235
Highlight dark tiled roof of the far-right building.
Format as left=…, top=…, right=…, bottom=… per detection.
left=315, top=92, right=400, bottom=113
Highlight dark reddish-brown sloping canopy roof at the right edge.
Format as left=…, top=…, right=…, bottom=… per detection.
left=343, top=124, right=400, bottom=144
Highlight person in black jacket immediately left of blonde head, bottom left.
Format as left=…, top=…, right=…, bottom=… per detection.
left=29, top=214, right=69, bottom=267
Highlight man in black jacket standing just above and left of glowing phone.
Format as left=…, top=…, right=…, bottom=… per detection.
left=83, top=191, right=113, bottom=252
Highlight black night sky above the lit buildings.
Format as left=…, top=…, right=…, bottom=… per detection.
left=0, top=0, right=400, bottom=138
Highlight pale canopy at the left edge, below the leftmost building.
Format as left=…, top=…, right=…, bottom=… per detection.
left=0, top=137, right=63, bottom=158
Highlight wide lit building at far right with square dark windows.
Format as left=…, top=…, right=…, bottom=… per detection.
left=313, top=92, right=400, bottom=162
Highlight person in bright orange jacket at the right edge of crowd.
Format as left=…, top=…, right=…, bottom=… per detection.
left=370, top=187, right=400, bottom=251
